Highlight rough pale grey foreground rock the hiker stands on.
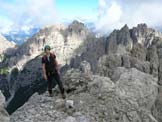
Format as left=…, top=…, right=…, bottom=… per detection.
left=11, top=62, right=158, bottom=122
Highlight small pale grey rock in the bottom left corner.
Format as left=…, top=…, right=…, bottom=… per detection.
left=0, top=91, right=10, bottom=122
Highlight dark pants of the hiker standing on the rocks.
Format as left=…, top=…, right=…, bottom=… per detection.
left=46, top=72, right=64, bottom=94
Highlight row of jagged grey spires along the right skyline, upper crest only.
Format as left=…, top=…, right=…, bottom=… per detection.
left=106, top=24, right=162, bottom=53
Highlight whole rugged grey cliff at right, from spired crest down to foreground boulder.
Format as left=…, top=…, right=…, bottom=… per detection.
left=106, top=24, right=162, bottom=79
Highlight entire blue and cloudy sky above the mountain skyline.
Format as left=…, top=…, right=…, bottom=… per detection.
left=0, top=0, right=162, bottom=33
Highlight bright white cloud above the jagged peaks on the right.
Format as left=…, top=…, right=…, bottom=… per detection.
left=95, top=0, right=162, bottom=33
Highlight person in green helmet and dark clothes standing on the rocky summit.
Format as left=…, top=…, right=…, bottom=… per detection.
left=42, top=45, right=66, bottom=99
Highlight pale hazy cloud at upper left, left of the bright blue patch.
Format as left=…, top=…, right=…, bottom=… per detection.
left=0, top=0, right=57, bottom=31
